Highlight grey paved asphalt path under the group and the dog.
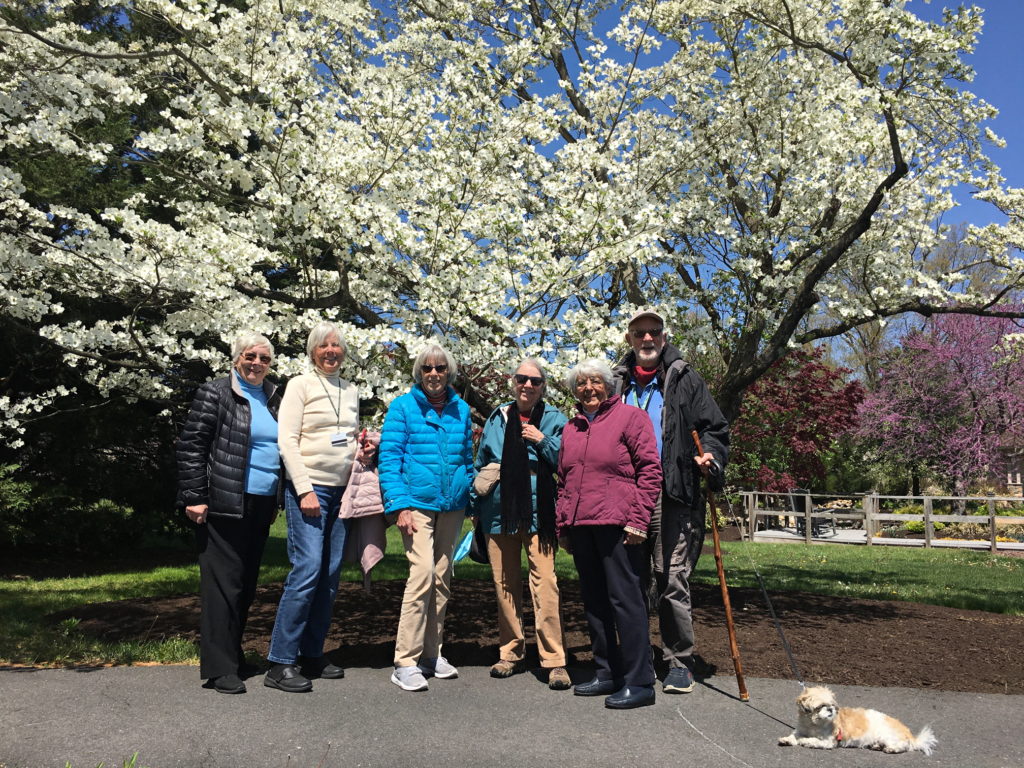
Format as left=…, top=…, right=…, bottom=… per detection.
left=0, top=659, right=1024, bottom=768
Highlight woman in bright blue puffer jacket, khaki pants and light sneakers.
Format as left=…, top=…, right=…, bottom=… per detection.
left=379, top=344, right=473, bottom=690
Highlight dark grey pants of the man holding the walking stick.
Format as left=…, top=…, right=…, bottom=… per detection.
left=646, top=494, right=705, bottom=667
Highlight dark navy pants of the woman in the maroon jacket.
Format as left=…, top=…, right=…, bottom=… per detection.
left=568, top=525, right=654, bottom=686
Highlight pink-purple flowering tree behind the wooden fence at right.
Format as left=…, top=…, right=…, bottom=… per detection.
left=858, top=315, right=1024, bottom=496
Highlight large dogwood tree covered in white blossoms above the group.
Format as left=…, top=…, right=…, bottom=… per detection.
left=0, top=0, right=1024, bottom=456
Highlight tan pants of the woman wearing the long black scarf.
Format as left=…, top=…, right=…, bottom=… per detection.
left=487, top=534, right=565, bottom=669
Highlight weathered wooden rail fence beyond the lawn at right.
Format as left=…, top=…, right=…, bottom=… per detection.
left=740, top=490, right=1024, bottom=552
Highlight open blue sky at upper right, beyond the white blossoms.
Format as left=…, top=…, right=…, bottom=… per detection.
left=921, top=0, right=1024, bottom=224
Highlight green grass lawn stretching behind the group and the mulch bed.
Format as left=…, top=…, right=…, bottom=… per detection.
left=0, top=519, right=1024, bottom=665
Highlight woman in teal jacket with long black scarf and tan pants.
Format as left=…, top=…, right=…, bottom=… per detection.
left=471, top=357, right=571, bottom=690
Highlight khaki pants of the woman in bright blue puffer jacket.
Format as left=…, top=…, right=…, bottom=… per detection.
left=394, top=509, right=466, bottom=667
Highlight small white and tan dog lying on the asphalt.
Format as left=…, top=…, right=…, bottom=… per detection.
left=778, top=686, right=935, bottom=755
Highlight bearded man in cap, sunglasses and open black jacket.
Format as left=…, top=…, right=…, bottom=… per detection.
left=614, top=311, right=729, bottom=693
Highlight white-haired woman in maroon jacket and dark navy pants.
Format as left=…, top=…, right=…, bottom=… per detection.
left=555, top=359, right=662, bottom=710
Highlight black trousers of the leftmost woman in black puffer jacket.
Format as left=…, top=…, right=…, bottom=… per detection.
left=196, top=494, right=278, bottom=679
